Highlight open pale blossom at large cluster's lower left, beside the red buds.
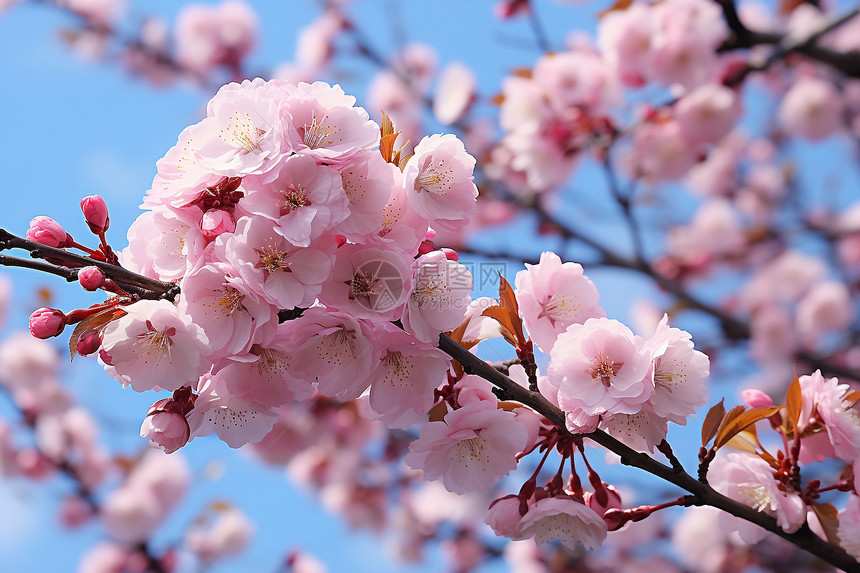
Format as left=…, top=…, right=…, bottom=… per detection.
left=100, top=300, right=209, bottom=392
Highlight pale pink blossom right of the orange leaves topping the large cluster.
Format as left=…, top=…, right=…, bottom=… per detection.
left=403, top=134, right=478, bottom=229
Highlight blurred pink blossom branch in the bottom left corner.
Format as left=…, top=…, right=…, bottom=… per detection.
left=0, top=320, right=253, bottom=573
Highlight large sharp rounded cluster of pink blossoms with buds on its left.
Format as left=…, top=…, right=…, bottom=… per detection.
left=23, top=79, right=477, bottom=451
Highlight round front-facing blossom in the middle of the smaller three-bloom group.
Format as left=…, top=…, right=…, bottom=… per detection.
left=547, top=318, right=653, bottom=422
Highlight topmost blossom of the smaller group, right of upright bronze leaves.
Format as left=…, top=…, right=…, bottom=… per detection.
left=515, top=252, right=606, bottom=353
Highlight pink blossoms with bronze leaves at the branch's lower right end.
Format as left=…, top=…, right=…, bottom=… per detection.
left=688, top=371, right=860, bottom=559
